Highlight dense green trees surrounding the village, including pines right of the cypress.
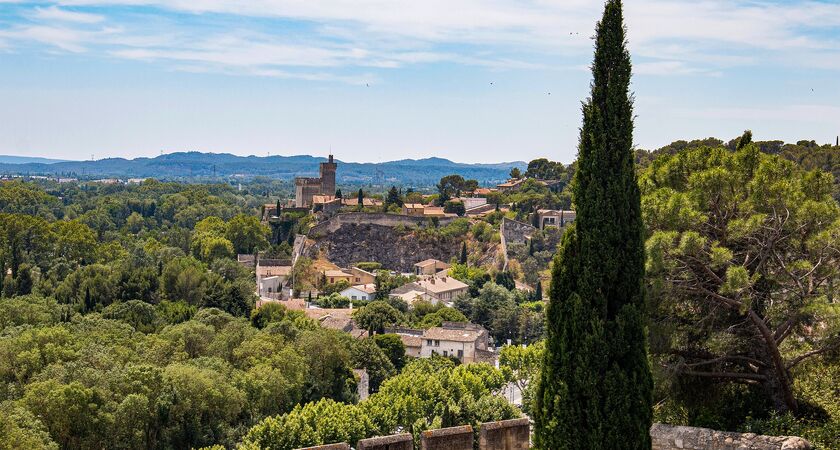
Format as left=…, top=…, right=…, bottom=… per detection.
left=0, top=134, right=840, bottom=449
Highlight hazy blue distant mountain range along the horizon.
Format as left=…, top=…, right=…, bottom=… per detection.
left=0, top=152, right=527, bottom=186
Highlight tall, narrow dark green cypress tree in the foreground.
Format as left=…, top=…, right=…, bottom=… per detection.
left=534, top=0, right=653, bottom=450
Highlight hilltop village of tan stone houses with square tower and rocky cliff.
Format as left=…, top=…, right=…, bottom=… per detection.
left=253, top=155, right=575, bottom=365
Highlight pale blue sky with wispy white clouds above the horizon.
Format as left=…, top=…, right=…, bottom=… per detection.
left=0, top=0, right=840, bottom=162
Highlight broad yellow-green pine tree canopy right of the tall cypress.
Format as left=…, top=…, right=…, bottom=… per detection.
left=641, top=144, right=840, bottom=412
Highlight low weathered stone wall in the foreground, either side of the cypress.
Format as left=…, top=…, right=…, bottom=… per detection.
left=296, top=418, right=813, bottom=450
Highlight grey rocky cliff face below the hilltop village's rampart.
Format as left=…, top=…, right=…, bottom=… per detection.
left=305, top=224, right=461, bottom=272
